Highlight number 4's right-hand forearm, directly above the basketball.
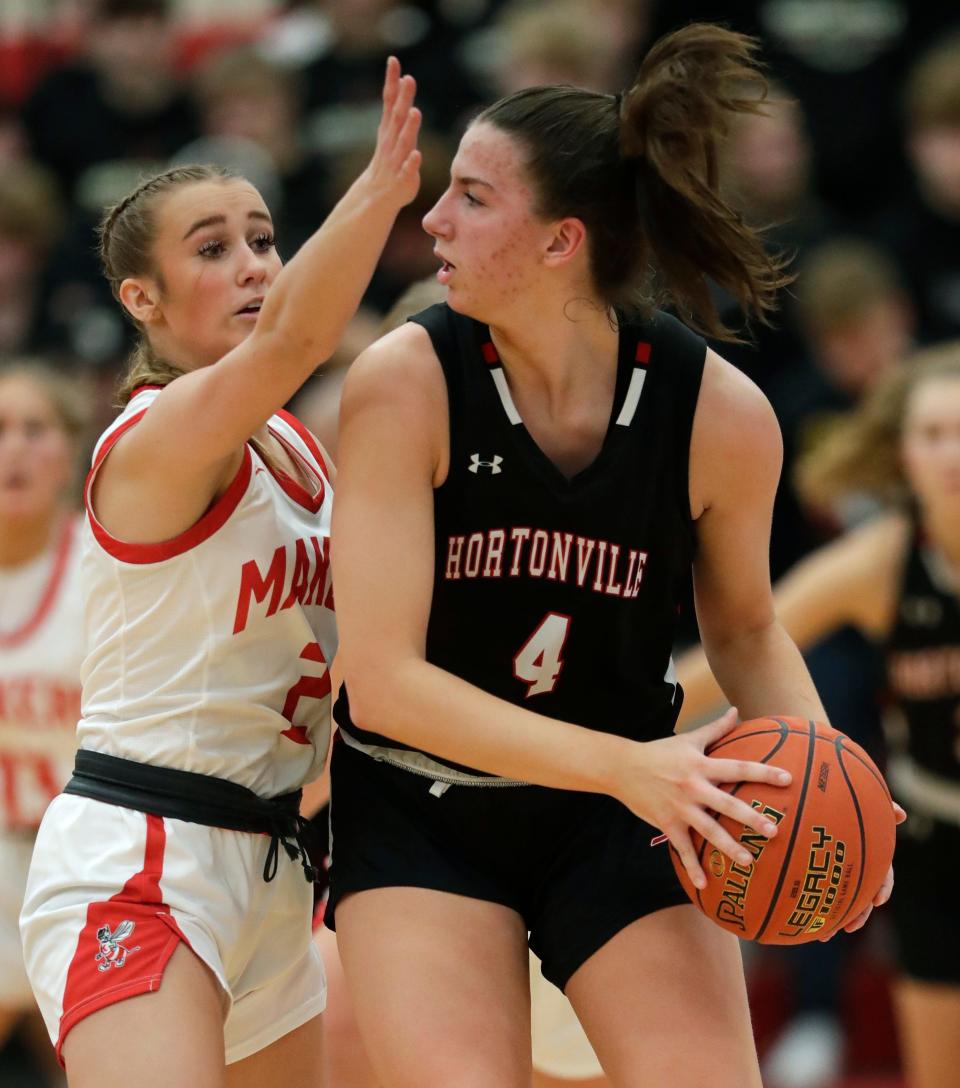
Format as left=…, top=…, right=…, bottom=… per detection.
left=704, top=620, right=826, bottom=721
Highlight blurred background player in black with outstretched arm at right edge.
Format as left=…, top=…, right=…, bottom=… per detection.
left=677, top=342, right=960, bottom=1088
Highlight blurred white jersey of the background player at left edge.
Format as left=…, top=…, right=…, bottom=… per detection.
left=0, top=517, right=84, bottom=831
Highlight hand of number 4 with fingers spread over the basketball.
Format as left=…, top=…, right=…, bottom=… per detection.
left=614, top=707, right=790, bottom=888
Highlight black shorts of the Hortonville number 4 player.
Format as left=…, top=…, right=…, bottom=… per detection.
left=324, top=739, right=690, bottom=989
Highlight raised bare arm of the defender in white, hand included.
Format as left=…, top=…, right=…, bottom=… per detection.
left=98, top=58, right=420, bottom=524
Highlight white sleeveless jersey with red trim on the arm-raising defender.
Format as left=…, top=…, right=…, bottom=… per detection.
left=78, top=388, right=336, bottom=798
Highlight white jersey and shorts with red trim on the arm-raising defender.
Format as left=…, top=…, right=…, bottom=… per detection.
left=21, top=388, right=336, bottom=1061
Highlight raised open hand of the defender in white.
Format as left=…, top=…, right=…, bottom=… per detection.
left=362, top=57, right=421, bottom=208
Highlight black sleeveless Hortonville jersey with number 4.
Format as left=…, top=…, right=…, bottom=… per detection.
left=334, top=304, right=706, bottom=770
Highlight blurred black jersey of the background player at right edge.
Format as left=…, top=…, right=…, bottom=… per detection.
left=886, top=533, right=960, bottom=784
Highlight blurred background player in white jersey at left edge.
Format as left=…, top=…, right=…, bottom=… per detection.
left=0, top=362, right=85, bottom=1044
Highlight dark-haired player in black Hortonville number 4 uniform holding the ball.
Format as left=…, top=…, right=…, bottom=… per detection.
left=328, top=26, right=896, bottom=1088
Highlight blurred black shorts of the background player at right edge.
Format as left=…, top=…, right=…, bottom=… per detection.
left=890, top=811, right=960, bottom=986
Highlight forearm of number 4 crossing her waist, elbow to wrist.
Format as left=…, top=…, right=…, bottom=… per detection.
left=347, top=658, right=635, bottom=793
